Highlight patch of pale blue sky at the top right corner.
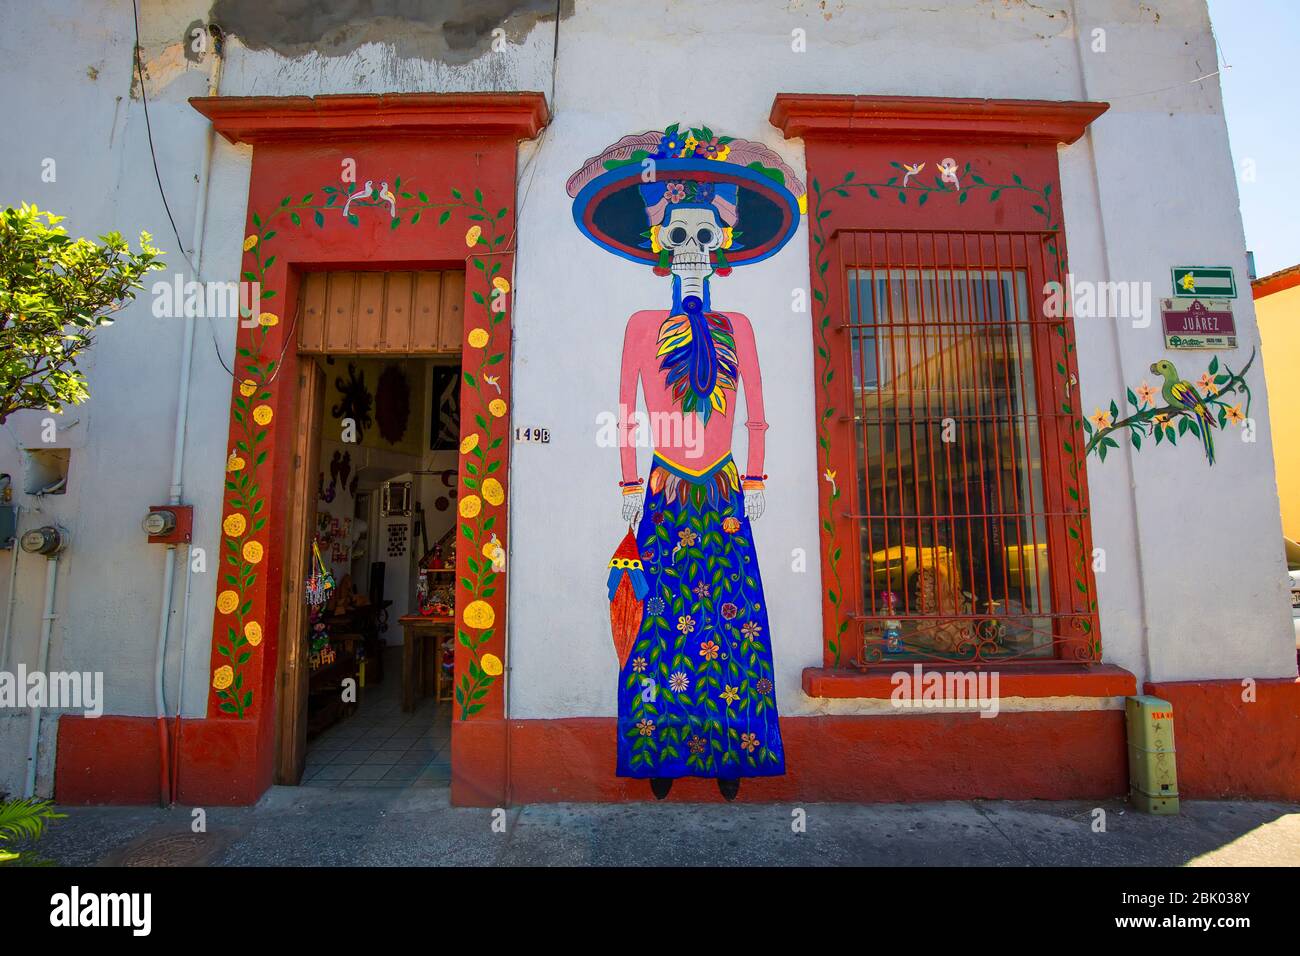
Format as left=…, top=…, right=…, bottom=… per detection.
left=1209, top=0, right=1300, bottom=276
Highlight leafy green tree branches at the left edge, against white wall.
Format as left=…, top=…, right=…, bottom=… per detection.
left=0, top=203, right=163, bottom=424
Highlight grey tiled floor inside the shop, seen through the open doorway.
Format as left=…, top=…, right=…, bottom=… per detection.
left=302, top=648, right=451, bottom=788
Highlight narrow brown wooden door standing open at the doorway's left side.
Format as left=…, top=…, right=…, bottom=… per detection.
left=276, top=358, right=325, bottom=786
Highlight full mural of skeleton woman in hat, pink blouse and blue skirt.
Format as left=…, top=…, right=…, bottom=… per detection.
left=568, top=124, right=805, bottom=800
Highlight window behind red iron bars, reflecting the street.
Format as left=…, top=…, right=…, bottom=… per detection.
left=841, top=232, right=1078, bottom=665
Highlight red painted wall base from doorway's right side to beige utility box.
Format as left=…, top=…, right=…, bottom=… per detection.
left=451, top=710, right=1128, bottom=806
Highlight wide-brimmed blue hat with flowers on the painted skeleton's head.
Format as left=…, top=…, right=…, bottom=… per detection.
left=568, top=124, right=807, bottom=267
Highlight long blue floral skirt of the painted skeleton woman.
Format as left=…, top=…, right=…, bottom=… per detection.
left=618, top=455, right=785, bottom=778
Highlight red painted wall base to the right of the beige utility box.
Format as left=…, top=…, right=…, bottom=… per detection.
left=1145, top=678, right=1300, bottom=800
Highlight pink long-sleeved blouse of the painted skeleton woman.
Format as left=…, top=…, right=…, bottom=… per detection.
left=619, top=310, right=767, bottom=481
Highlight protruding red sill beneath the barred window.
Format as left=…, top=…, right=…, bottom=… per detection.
left=803, top=661, right=1138, bottom=700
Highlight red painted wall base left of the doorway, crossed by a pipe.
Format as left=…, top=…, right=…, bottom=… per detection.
left=55, top=715, right=270, bottom=805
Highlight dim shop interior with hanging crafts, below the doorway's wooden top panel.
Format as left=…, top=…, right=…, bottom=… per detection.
left=300, top=355, right=460, bottom=787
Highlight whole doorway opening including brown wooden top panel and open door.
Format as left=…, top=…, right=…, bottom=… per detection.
left=278, top=267, right=464, bottom=788
